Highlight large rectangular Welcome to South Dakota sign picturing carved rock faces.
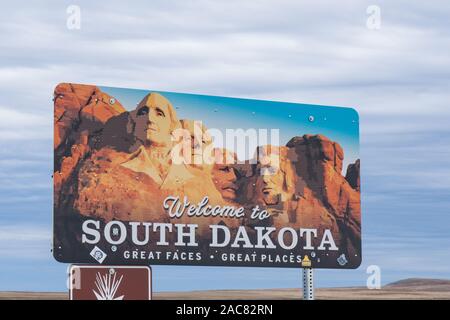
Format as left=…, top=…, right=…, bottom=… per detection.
left=53, top=83, right=361, bottom=268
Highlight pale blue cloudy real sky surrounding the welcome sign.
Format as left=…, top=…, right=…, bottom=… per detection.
left=0, top=0, right=450, bottom=291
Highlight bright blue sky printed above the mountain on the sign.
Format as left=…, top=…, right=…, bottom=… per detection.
left=100, top=86, right=359, bottom=170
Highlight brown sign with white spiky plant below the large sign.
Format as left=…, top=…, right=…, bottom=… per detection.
left=69, top=265, right=152, bottom=300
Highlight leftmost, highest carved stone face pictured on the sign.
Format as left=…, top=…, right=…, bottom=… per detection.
left=133, top=93, right=178, bottom=146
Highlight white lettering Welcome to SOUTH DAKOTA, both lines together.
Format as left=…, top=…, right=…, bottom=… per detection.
left=81, top=196, right=338, bottom=251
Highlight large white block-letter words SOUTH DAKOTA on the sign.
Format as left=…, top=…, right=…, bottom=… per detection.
left=81, top=219, right=338, bottom=251
